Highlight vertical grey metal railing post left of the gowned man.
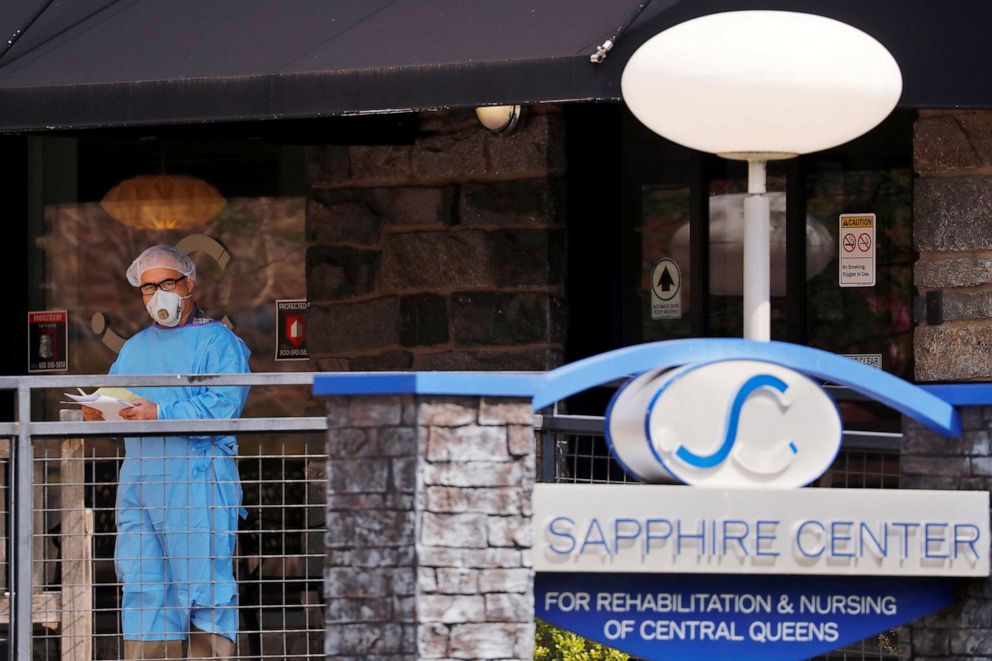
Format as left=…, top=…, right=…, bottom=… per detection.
left=9, top=384, right=34, bottom=661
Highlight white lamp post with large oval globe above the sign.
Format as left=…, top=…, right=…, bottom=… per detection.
left=621, top=11, right=902, bottom=341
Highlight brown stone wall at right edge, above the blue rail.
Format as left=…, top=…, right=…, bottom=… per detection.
left=913, top=110, right=992, bottom=381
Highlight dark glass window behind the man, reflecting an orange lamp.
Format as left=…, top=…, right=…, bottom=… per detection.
left=28, top=137, right=312, bottom=415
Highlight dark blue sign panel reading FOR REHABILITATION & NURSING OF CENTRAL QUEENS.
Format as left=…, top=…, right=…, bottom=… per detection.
left=534, top=574, right=954, bottom=661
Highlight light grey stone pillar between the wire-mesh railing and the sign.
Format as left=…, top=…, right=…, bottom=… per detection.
left=325, top=395, right=535, bottom=659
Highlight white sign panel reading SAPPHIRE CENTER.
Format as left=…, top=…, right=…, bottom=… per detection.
left=534, top=484, right=989, bottom=576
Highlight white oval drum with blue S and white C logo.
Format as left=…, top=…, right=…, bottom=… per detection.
left=607, top=360, right=841, bottom=487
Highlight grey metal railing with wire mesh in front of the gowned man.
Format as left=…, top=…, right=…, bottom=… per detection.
left=0, top=373, right=327, bottom=660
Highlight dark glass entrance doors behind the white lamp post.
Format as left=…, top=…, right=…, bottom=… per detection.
left=623, top=112, right=915, bottom=429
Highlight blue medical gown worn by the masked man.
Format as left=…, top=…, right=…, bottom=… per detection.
left=110, top=319, right=250, bottom=640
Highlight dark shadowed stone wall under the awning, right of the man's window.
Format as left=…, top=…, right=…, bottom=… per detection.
left=306, top=107, right=565, bottom=371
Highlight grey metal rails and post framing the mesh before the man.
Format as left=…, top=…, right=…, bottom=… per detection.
left=0, top=372, right=327, bottom=660
